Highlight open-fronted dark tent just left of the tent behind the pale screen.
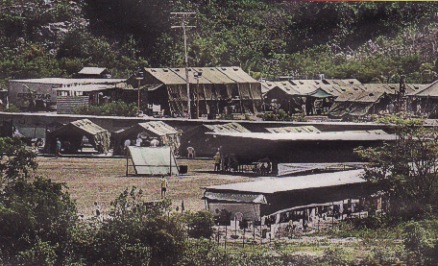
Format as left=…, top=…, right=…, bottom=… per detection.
left=45, top=119, right=110, bottom=153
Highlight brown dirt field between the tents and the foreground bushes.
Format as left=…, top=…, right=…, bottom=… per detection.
left=37, top=157, right=254, bottom=215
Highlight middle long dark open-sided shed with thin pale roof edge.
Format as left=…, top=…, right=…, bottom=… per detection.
left=205, top=127, right=396, bottom=167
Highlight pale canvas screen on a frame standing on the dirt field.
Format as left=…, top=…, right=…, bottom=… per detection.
left=126, top=146, right=179, bottom=176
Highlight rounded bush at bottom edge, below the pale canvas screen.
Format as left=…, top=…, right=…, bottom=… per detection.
left=87, top=187, right=185, bottom=265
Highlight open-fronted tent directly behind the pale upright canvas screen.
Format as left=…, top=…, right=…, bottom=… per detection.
left=111, top=121, right=181, bottom=154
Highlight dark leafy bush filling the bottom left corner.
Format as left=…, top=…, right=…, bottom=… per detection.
left=0, top=177, right=77, bottom=264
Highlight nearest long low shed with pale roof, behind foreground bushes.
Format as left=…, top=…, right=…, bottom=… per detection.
left=203, top=169, right=382, bottom=223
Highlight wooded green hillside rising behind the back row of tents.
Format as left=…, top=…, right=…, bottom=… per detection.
left=0, top=0, right=438, bottom=87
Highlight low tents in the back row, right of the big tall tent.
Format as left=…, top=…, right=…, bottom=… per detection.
left=262, top=79, right=430, bottom=118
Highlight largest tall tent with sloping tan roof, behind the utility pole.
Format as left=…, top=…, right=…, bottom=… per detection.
left=128, top=67, right=262, bottom=117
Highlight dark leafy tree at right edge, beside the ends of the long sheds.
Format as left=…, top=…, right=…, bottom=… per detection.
left=356, top=117, right=438, bottom=216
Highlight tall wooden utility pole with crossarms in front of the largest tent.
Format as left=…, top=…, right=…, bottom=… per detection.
left=170, top=12, right=196, bottom=119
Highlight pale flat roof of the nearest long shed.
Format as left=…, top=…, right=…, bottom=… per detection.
left=206, top=169, right=366, bottom=194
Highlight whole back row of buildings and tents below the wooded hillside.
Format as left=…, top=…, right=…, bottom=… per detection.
left=8, top=67, right=438, bottom=119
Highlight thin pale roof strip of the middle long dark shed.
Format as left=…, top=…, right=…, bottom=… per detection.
left=205, top=130, right=396, bottom=141
